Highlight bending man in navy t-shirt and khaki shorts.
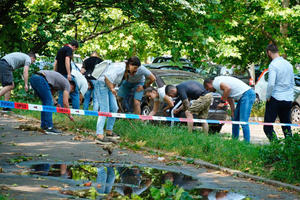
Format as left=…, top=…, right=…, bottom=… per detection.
left=166, top=81, right=212, bottom=132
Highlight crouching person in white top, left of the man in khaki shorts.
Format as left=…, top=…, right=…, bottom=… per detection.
left=144, top=86, right=174, bottom=116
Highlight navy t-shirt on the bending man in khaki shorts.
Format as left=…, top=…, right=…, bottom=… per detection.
left=176, top=81, right=208, bottom=101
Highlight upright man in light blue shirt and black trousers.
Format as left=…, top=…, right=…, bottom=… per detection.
left=264, top=44, right=295, bottom=141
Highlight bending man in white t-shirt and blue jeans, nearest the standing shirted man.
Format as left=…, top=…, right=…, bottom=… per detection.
left=204, top=76, right=255, bottom=143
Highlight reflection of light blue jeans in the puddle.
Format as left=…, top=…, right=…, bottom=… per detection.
left=96, top=167, right=116, bottom=194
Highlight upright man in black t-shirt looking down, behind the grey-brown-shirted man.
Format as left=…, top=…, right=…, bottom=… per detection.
left=54, top=40, right=79, bottom=109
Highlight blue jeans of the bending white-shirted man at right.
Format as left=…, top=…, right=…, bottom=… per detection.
left=232, top=89, right=255, bottom=143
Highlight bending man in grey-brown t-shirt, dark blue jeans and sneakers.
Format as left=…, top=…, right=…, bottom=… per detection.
left=29, top=70, right=75, bottom=134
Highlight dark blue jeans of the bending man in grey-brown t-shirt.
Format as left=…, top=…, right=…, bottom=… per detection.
left=29, top=74, right=53, bottom=129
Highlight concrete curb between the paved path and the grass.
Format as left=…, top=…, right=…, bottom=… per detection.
left=141, top=147, right=300, bottom=192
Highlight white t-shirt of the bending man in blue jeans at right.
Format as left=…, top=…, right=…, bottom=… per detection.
left=212, top=76, right=251, bottom=101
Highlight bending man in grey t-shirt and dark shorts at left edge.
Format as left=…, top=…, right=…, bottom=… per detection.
left=0, top=52, right=36, bottom=106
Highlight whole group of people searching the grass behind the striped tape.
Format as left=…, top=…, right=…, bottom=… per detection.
left=0, top=41, right=294, bottom=144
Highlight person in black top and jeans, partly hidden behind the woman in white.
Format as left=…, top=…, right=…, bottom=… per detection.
left=81, top=51, right=103, bottom=111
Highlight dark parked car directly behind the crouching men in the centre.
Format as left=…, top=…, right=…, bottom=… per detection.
left=141, top=69, right=227, bottom=132
